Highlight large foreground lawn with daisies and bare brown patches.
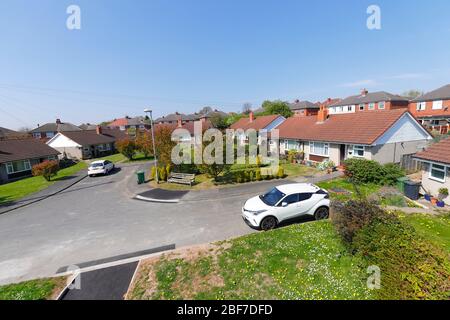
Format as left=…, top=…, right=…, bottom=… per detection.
left=128, top=221, right=372, bottom=300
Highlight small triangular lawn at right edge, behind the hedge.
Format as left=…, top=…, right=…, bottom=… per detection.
left=401, top=214, right=450, bottom=253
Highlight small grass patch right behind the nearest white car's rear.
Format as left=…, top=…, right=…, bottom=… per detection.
left=317, top=178, right=381, bottom=201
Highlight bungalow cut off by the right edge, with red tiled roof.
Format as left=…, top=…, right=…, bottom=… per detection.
left=414, top=138, right=450, bottom=205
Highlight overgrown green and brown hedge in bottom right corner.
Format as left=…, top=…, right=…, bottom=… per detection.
left=332, top=201, right=450, bottom=300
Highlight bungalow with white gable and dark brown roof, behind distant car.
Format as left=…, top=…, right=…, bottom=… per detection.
left=47, top=128, right=116, bottom=160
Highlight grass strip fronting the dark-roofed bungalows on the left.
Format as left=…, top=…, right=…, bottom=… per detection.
left=0, top=162, right=87, bottom=204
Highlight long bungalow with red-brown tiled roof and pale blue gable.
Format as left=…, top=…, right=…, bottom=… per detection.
left=277, top=106, right=432, bottom=165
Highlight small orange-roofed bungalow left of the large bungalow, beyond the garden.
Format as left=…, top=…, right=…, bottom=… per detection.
left=230, top=112, right=286, bottom=148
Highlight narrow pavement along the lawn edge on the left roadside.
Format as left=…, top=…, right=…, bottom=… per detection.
left=0, top=169, right=87, bottom=214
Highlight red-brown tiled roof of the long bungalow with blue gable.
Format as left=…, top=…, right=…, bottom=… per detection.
left=277, top=109, right=407, bottom=145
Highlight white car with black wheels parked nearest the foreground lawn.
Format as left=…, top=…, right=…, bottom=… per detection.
left=242, top=183, right=330, bottom=231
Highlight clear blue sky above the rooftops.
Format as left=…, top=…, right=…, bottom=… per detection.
left=0, top=0, right=450, bottom=129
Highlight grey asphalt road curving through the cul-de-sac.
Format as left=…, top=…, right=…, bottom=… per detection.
left=0, top=167, right=254, bottom=284
